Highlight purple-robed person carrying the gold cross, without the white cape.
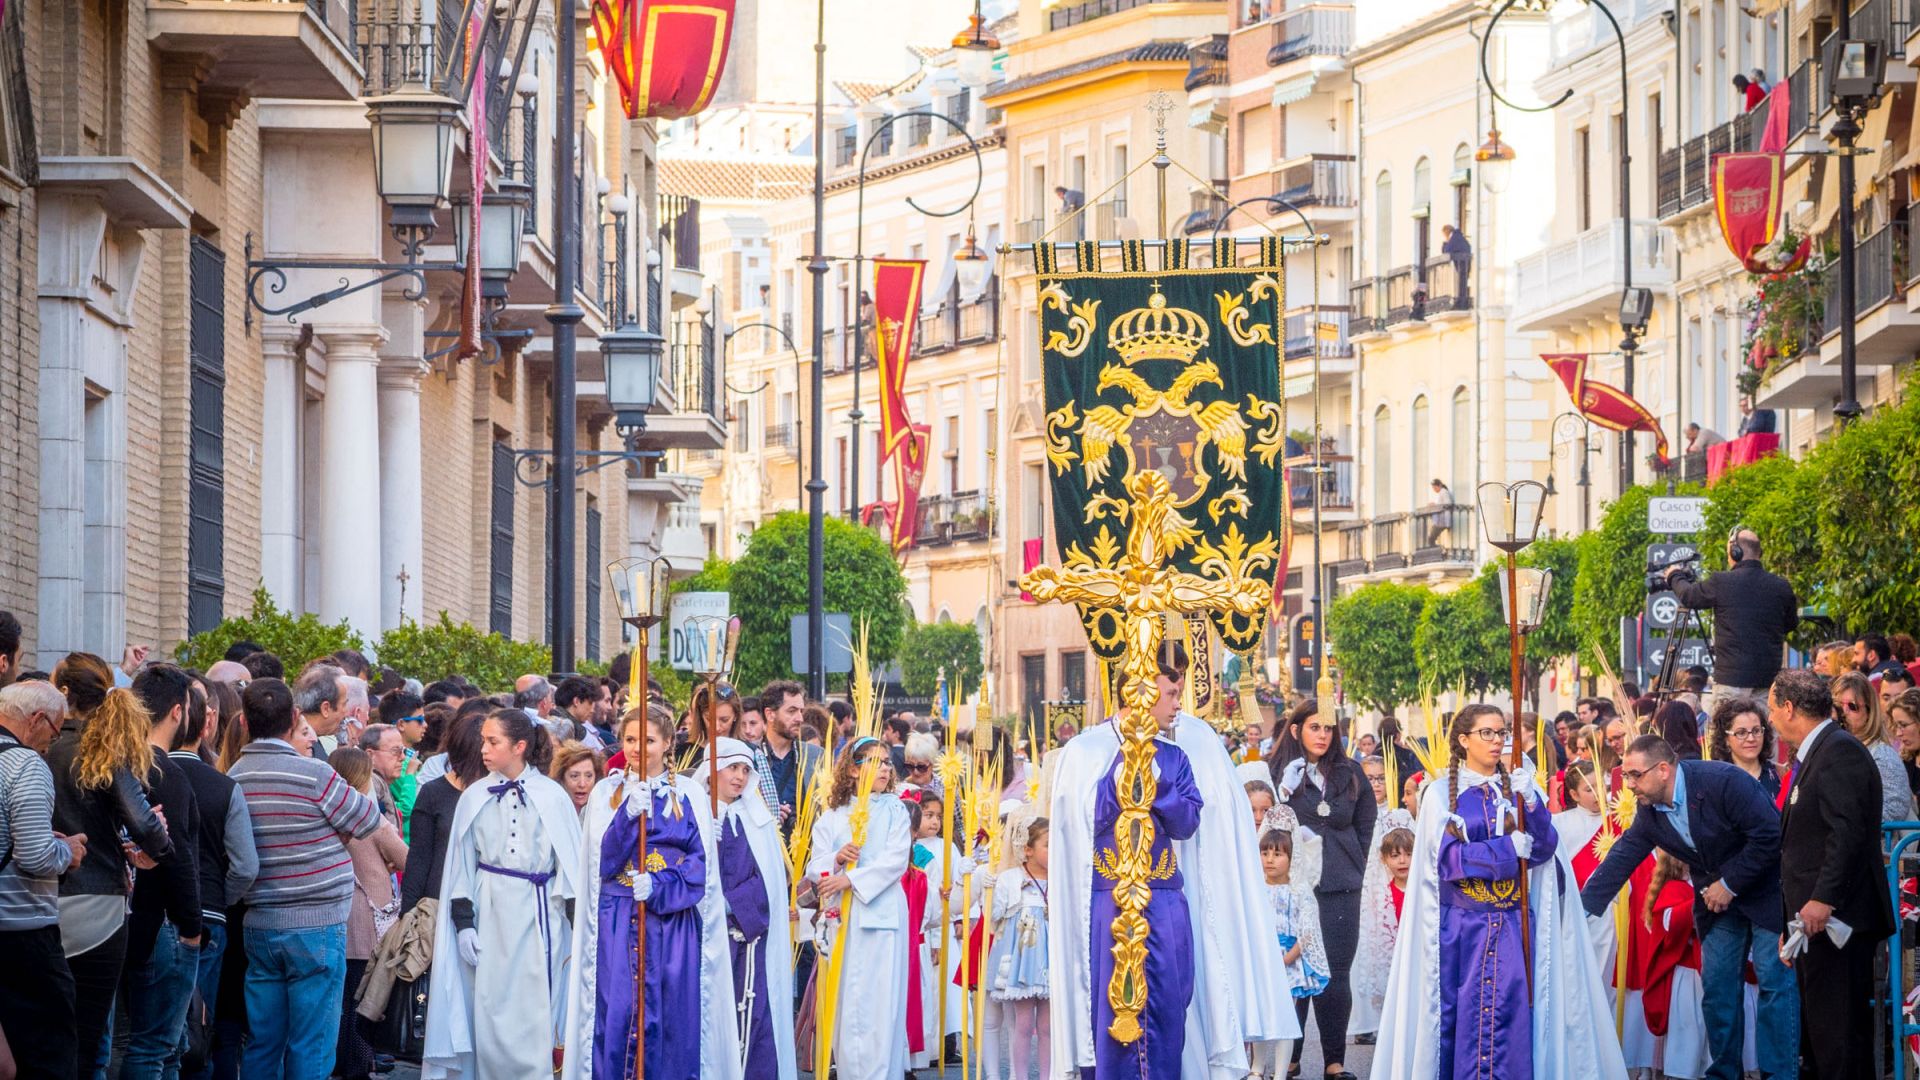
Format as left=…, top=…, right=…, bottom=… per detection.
left=1081, top=661, right=1200, bottom=1080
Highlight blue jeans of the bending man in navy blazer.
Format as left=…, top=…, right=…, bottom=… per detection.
left=1699, top=911, right=1799, bottom=1080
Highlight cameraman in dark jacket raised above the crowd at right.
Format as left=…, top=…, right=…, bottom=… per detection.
left=1667, top=528, right=1799, bottom=711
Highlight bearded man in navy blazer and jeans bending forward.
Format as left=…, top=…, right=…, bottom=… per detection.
left=1580, top=734, right=1789, bottom=1080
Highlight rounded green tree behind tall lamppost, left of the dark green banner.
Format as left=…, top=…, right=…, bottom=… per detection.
left=728, top=511, right=908, bottom=686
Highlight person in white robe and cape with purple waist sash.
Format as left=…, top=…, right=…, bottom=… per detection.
left=420, top=709, right=582, bottom=1080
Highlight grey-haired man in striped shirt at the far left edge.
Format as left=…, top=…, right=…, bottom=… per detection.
left=0, top=676, right=86, bottom=1080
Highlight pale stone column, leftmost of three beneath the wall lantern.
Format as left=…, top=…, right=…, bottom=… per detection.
left=259, top=319, right=307, bottom=611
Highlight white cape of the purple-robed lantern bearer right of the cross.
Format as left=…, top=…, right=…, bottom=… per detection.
left=1373, top=767, right=1626, bottom=1080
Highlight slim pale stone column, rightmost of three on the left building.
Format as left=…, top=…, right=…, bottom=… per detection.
left=380, top=356, right=426, bottom=630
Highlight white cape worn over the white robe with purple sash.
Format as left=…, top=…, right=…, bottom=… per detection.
left=420, top=769, right=591, bottom=1080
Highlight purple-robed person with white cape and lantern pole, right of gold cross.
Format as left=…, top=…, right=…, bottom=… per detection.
left=1373, top=705, right=1626, bottom=1080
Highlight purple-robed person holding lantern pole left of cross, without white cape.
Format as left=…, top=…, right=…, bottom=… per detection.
left=589, top=703, right=707, bottom=1080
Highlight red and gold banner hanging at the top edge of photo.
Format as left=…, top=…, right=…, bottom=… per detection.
left=593, top=0, right=733, bottom=119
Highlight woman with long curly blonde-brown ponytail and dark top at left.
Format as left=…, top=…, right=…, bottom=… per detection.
left=46, top=653, right=184, bottom=1076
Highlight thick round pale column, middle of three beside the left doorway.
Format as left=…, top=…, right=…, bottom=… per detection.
left=319, top=327, right=386, bottom=640
